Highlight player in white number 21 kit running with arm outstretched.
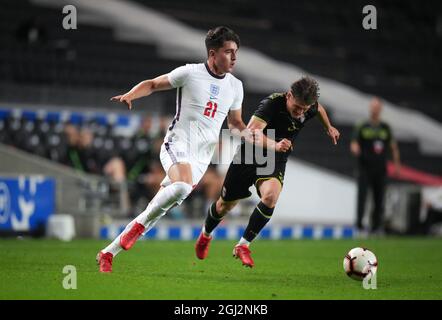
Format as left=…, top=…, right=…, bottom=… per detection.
left=97, top=27, right=246, bottom=272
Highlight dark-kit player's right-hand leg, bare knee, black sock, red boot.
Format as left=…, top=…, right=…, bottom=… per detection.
left=233, top=178, right=281, bottom=268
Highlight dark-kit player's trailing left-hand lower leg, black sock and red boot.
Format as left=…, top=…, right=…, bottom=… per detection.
left=195, top=197, right=238, bottom=259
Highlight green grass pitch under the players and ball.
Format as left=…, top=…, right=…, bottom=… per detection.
left=0, top=238, right=442, bottom=300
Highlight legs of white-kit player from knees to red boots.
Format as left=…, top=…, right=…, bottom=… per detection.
left=98, top=163, right=192, bottom=272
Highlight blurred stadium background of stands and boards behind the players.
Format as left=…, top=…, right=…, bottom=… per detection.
left=0, top=0, right=442, bottom=240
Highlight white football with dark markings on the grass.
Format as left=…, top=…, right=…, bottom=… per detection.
left=344, top=247, right=378, bottom=281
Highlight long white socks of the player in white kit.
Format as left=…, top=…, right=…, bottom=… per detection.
left=102, top=181, right=192, bottom=257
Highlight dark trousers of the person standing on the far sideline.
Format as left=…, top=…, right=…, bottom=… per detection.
left=356, top=167, right=387, bottom=231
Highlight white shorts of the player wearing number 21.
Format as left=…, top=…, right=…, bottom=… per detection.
left=160, top=141, right=209, bottom=187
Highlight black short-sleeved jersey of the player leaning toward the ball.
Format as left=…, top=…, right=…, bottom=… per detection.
left=242, top=93, right=318, bottom=162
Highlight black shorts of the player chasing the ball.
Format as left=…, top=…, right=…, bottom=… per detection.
left=221, top=162, right=286, bottom=201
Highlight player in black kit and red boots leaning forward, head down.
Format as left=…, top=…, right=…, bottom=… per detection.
left=195, top=77, right=340, bottom=267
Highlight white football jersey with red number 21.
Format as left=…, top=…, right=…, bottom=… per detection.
left=164, top=63, right=244, bottom=163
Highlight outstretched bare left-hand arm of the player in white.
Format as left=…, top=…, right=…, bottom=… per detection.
left=111, top=74, right=172, bottom=110
